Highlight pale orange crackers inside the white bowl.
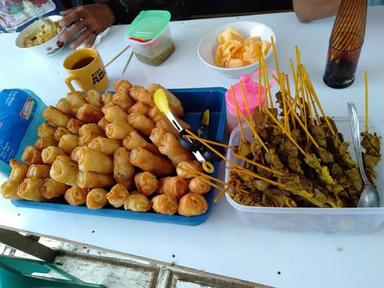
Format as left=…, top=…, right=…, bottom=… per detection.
left=215, top=28, right=271, bottom=68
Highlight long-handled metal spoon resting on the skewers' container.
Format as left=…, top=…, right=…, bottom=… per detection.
left=348, top=103, right=380, bottom=207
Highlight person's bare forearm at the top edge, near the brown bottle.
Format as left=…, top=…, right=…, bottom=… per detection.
left=293, top=0, right=341, bottom=22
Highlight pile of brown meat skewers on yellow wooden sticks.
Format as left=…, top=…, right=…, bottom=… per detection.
left=228, top=64, right=381, bottom=208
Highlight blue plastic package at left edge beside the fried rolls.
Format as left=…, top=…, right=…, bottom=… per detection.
left=0, top=89, right=46, bottom=176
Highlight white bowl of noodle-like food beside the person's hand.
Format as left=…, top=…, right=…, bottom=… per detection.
left=16, top=15, right=64, bottom=57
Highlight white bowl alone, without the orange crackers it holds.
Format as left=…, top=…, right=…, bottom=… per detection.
left=197, top=21, right=276, bottom=78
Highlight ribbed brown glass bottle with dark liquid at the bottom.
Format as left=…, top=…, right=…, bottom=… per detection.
left=323, top=0, right=367, bottom=88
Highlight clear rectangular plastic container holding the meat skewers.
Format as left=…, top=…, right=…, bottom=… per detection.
left=225, top=117, right=384, bottom=233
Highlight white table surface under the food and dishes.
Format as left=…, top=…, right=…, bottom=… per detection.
left=0, top=7, right=384, bottom=287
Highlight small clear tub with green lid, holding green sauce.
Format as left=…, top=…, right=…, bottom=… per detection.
left=126, top=10, right=175, bottom=66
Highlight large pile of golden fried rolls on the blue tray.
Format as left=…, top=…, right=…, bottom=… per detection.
left=1, top=80, right=210, bottom=216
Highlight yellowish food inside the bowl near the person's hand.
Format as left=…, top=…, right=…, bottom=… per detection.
left=23, top=20, right=63, bottom=47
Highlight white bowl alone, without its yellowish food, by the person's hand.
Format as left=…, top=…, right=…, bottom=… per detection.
left=15, top=15, right=64, bottom=57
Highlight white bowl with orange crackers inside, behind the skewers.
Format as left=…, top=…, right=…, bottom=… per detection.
left=197, top=21, right=276, bottom=78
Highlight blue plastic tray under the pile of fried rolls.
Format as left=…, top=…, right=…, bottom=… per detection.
left=12, top=88, right=226, bottom=226
